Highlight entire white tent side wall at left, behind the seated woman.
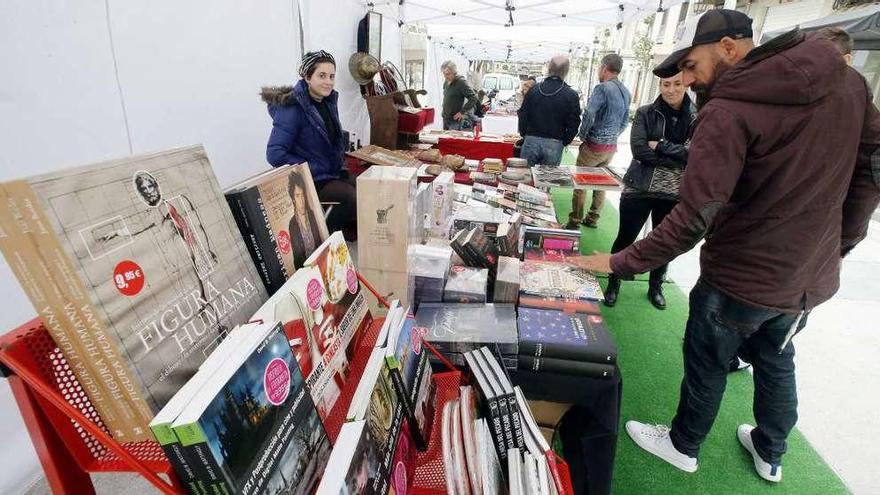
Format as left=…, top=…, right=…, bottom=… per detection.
left=0, top=0, right=400, bottom=494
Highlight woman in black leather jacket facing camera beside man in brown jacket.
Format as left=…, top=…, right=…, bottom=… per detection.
left=605, top=74, right=696, bottom=309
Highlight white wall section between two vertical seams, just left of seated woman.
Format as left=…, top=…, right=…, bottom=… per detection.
left=110, top=0, right=299, bottom=184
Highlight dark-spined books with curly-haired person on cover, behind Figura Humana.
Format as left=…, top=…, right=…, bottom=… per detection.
left=224, top=163, right=329, bottom=295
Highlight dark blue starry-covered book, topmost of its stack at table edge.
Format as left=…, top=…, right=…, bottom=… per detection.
left=517, top=307, right=617, bottom=371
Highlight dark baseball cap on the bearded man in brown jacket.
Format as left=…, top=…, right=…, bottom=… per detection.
left=654, top=9, right=752, bottom=77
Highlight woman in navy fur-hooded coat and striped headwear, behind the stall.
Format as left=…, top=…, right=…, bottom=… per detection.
left=261, top=50, right=357, bottom=241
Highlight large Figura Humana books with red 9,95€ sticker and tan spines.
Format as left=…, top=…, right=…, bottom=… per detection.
left=0, top=146, right=267, bottom=441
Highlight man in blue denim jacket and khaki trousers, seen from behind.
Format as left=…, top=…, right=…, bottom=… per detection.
left=566, top=53, right=632, bottom=230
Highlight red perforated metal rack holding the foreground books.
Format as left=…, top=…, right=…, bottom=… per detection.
left=0, top=275, right=574, bottom=495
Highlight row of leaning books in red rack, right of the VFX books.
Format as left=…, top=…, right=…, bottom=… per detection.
left=317, top=301, right=433, bottom=495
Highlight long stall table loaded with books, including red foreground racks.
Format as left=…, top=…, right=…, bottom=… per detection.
left=0, top=146, right=620, bottom=495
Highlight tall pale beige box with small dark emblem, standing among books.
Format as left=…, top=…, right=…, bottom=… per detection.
left=357, top=166, right=417, bottom=272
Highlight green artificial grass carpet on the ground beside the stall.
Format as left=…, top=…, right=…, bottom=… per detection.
left=552, top=185, right=847, bottom=495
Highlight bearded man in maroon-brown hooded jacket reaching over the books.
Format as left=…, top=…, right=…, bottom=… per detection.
left=581, top=9, right=880, bottom=481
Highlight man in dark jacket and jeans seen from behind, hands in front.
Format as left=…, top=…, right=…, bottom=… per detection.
left=518, top=55, right=581, bottom=166
